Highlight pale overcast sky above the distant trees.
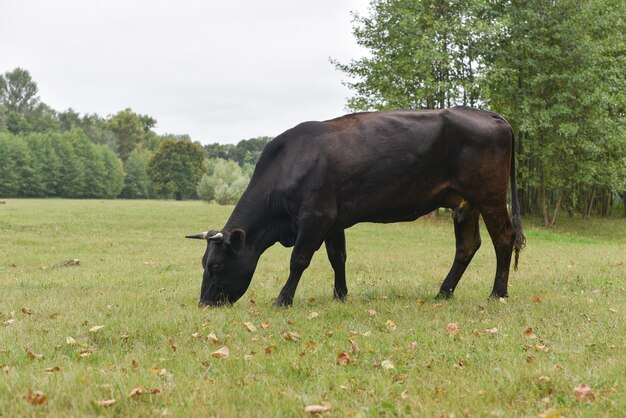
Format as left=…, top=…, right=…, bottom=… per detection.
left=0, top=0, right=369, bottom=144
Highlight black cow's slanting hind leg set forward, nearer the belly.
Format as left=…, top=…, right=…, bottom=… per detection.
left=437, top=205, right=480, bottom=299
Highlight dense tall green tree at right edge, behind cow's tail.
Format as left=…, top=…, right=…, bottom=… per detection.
left=486, top=0, right=626, bottom=225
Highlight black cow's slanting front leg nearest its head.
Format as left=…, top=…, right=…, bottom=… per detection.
left=274, top=217, right=328, bottom=306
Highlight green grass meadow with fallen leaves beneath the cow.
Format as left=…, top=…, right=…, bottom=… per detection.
left=0, top=200, right=626, bottom=417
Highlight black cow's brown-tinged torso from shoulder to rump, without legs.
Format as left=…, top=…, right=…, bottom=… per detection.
left=253, top=108, right=511, bottom=226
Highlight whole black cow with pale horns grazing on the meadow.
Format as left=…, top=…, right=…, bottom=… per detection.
left=187, top=107, right=525, bottom=306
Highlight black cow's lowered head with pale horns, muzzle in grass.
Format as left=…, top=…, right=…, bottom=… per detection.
left=185, top=229, right=258, bottom=306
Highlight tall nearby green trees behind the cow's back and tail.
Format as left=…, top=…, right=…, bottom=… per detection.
left=334, top=0, right=626, bottom=225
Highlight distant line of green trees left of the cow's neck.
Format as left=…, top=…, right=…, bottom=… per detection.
left=0, top=68, right=271, bottom=204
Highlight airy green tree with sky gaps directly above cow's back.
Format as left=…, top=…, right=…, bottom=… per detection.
left=333, top=0, right=494, bottom=110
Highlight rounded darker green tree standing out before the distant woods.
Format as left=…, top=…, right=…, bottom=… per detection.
left=147, top=140, right=205, bottom=200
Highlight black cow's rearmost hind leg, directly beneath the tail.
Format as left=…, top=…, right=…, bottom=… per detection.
left=481, top=204, right=515, bottom=299
